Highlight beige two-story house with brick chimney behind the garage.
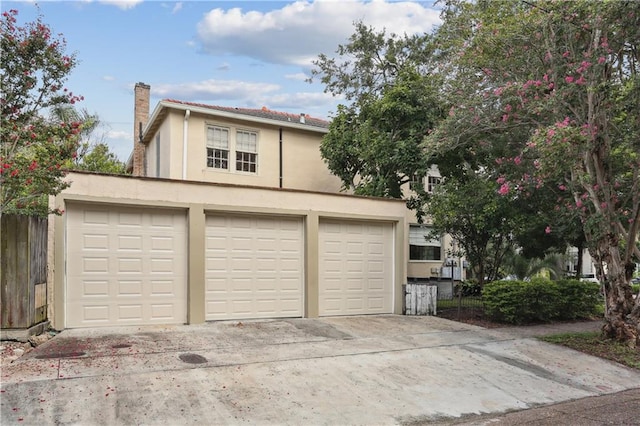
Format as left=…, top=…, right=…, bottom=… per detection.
left=129, top=83, right=461, bottom=281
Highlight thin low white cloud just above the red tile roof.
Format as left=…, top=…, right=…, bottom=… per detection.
left=151, top=80, right=281, bottom=101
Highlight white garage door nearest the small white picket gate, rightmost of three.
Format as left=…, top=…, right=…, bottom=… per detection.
left=318, top=221, right=393, bottom=316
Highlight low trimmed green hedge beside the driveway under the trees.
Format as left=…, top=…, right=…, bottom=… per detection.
left=482, top=278, right=602, bottom=324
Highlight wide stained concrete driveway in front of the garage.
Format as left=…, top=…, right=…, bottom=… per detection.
left=0, top=315, right=640, bottom=425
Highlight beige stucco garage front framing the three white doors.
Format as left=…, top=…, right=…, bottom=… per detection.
left=48, top=172, right=407, bottom=329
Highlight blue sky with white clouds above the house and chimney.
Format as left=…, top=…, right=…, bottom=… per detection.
left=5, top=0, right=439, bottom=161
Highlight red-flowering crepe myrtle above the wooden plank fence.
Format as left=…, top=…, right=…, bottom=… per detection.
left=0, top=10, right=82, bottom=215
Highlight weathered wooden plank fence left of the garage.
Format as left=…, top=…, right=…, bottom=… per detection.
left=0, top=215, right=48, bottom=329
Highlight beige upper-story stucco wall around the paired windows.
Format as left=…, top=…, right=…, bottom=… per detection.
left=147, top=109, right=340, bottom=192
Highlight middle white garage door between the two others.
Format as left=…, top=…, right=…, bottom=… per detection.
left=205, top=215, right=304, bottom=320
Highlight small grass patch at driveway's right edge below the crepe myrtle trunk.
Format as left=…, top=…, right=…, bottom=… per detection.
left=538, top=331, right=640, bottom=370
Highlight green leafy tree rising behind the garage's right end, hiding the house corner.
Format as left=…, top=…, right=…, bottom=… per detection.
left=313, top=23, right=441, bottom=203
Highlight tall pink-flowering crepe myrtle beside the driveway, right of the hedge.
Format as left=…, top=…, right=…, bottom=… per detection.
left=427, top=0, right=640, bottom=346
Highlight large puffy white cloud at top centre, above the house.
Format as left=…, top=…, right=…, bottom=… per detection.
left=197, top=0, right=440, bottom=66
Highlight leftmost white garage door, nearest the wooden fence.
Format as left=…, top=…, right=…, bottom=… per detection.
left=66, top=205, right=187, bottom=328
